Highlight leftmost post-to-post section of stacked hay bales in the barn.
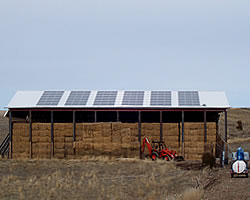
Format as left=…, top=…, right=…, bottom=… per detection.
left=12, top=123, right=30, bottom=158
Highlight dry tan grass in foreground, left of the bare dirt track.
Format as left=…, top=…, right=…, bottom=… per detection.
left=0, top=158, right=204, bottom=200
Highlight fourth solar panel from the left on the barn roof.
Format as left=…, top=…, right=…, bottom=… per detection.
left=122, top=91, right=144, bottom=106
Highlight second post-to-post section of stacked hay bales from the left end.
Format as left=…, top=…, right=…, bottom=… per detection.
left=32, top=123, right=51, bottom=158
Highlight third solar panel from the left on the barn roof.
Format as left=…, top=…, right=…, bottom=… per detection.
left=94, top=91, right=118, bottom=106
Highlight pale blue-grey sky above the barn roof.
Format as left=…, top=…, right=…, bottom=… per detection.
left=0, top=0, right=250, bottom=109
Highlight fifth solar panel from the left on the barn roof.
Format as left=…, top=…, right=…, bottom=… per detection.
left=150, top=91, right=172, bottom=106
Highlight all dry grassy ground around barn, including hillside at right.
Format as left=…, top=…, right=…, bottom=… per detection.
left=0, top=109, right=250, bottom=200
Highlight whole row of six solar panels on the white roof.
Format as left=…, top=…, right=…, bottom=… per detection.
left=36, top=91, right=200, bottom=106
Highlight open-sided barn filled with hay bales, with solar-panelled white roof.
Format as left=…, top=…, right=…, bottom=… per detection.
left=2, top=90, right=230, bottom=160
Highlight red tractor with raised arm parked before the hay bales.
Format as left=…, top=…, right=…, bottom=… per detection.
left=142, top=137, right=184, bottom=161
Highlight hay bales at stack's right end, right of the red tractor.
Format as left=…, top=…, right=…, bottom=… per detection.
left=184, top=122, right=216, bottom=160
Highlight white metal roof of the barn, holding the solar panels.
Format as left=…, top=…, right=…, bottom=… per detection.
left=6, top=90, right=230, bottom=109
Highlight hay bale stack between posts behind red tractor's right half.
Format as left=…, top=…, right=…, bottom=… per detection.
left=162, top=123, right=181, bottom=154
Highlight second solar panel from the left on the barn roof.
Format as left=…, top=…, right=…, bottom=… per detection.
left=65, top=91, right=91, bottom=105
